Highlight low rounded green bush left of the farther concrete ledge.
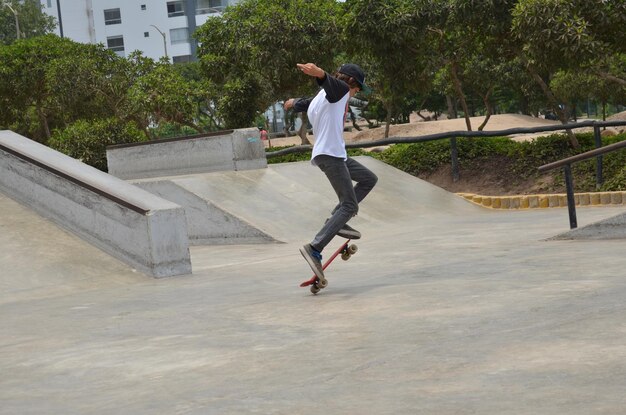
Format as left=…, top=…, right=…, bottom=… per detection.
left=48, top=118, right=146, bottom=171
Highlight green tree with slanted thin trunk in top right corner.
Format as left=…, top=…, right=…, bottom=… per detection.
left=512, top=0, right=626, bottom=147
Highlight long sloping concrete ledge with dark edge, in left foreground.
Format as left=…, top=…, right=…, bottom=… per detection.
left=0, top=131, right=191, bottom=277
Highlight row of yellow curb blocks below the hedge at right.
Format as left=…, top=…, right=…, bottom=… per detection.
left=457, top=192, right=626, bottom=210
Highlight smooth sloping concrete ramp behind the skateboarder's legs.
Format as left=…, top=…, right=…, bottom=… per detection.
left=135, top=157, right=488, bottom=243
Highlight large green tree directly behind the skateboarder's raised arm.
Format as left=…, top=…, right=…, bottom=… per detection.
left=195, top=0, right=342, bottom=140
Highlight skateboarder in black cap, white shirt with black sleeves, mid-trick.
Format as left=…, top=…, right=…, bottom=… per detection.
left=284, top=63, right=378, bottom=280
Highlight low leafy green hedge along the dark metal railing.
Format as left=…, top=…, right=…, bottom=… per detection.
left=268, top=133, right=626, bottom=192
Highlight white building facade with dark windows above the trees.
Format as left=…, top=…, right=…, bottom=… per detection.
left=41, top=0, right=238, bottom=63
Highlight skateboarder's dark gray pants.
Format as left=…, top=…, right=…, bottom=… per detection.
left=311, top=155, right=378, bottom=252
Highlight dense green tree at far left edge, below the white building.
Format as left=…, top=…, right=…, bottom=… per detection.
left=0, top=35, right=142, bottom=143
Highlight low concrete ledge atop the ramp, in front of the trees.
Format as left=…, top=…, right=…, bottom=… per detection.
left=107, top=128, right=267, bottom=179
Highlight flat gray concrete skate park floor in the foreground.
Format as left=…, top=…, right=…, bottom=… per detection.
left=0, top=158, right=626, bottom=414
